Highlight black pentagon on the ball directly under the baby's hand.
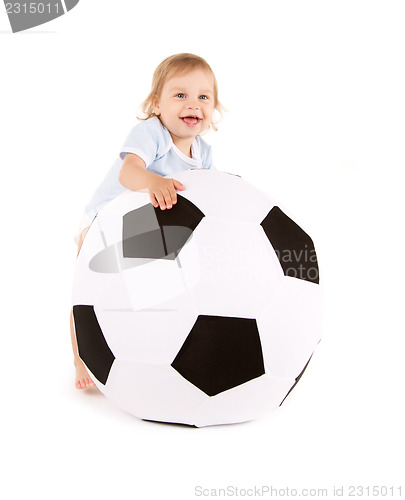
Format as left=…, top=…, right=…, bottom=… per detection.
left=122, top=194, right=204, bottom=260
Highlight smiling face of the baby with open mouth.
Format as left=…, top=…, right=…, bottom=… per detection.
left=153, top=69, right=214, bottom=155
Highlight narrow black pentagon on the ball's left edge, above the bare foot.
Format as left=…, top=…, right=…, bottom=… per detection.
left=73, top=305, right=115, bottom=384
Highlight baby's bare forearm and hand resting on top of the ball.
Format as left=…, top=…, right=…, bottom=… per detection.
left=118, top=153, right=186, bottom=210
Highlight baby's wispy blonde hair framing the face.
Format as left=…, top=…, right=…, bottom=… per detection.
left=138, top=52, right=224, bottom=130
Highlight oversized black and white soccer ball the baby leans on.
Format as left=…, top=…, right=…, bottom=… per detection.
left=73, top=169, right=320, bottom=427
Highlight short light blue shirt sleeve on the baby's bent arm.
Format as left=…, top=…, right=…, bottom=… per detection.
left=120, top=117, right=170, bottom=167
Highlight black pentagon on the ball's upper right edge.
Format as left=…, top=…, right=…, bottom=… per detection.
left=260, top=207, right=319, bottom=284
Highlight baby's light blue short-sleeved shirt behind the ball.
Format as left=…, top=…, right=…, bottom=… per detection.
left=81, top=116, right=215, bottom=223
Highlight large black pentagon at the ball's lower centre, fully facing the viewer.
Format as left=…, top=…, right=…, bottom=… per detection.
left=171, top=315, right=265, bottom=396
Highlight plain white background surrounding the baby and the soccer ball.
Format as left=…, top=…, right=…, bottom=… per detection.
left=0, top=0, right=405, bottom=500
